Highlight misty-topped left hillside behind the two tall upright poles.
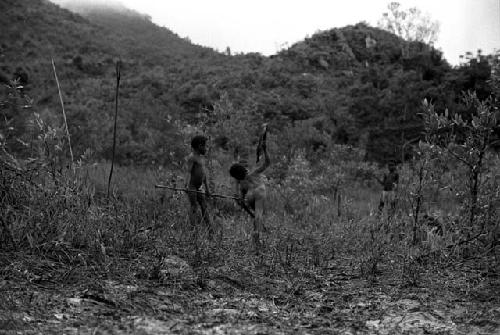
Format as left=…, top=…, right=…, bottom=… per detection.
left=0, top=0, right=225, bottom=162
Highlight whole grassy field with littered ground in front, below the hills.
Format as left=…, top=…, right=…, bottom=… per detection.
left=0, top=159, right=500, bottom=334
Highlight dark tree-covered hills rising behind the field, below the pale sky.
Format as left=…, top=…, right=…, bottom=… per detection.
left=0, top=0, right=493, bottom=167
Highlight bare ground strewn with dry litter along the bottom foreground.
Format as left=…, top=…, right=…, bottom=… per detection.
left=0, top=247, right=500, bottom=334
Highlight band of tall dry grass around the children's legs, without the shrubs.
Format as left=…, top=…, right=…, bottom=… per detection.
left=3, top=152, right=498, bottom=285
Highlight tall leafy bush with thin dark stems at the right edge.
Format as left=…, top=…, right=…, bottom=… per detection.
left=424, top=93, right=500, bottom=247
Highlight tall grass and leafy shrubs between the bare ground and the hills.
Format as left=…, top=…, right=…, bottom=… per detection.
left=0, top=56, right=500, bottom=285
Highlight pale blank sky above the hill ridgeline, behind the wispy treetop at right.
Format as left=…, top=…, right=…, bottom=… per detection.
left=71, top=0, right=500, bottom=64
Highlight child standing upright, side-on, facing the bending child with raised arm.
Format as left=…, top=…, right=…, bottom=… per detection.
left=184, top=135, right=212, bottom=232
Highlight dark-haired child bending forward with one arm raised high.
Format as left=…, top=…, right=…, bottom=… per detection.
left=229, top=128, right=271, bottom=247
